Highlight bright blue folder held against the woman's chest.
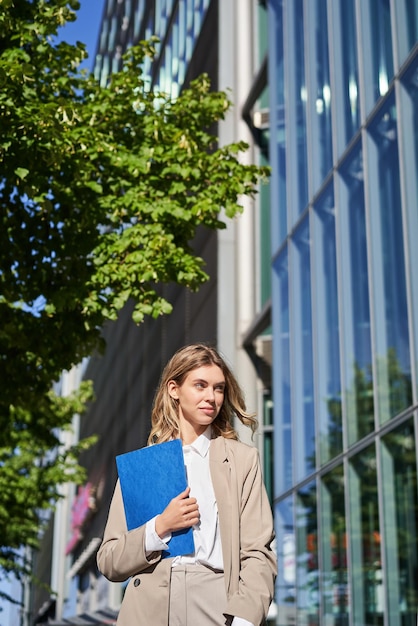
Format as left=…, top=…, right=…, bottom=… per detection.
left=116, top=439, right=195, bottom=558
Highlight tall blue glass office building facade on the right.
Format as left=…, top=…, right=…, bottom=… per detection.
left=269, top=0, right=418, bottom=626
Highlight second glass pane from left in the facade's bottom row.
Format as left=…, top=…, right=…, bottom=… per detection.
left=296, top=482, right=319, bottom=626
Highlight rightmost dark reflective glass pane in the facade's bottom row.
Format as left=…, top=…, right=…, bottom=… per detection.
left=382, top=419, right=418, bottom=626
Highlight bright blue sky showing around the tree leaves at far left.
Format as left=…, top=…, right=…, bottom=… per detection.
left=0, top=7, right=105, bottom=626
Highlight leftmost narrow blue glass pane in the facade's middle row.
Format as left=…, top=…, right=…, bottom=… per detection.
left=273, top=250, right=293, bottom=494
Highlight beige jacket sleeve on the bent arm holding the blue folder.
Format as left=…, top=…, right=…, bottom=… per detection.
left=97, top=480, right=161, bottom=582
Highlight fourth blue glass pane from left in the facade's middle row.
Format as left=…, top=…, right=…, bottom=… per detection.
left=339, top=144, right=374, bottom=444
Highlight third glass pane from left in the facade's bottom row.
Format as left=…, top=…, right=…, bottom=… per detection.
left=321, top=465, right=351, bottom=626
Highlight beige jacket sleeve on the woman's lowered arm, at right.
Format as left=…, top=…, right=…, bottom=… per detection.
left=226, top=448, right=277, bottom=626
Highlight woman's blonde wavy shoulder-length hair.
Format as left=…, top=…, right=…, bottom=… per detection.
left=148, top=343, right=257, bottom=445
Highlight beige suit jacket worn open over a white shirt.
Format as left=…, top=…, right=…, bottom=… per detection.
left=97, top=437, right=276, bottom=626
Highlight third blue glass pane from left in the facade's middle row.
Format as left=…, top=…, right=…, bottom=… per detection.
left=313, top=185, right=342, bottom=463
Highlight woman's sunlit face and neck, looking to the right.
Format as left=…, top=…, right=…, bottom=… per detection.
left=168, top=365, right=225, bottom=444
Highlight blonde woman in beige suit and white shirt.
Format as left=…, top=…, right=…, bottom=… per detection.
left=97, top=344, right=276, bottom=626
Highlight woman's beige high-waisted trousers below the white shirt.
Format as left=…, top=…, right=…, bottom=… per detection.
left=168, top=564, right=230, bottom=626
